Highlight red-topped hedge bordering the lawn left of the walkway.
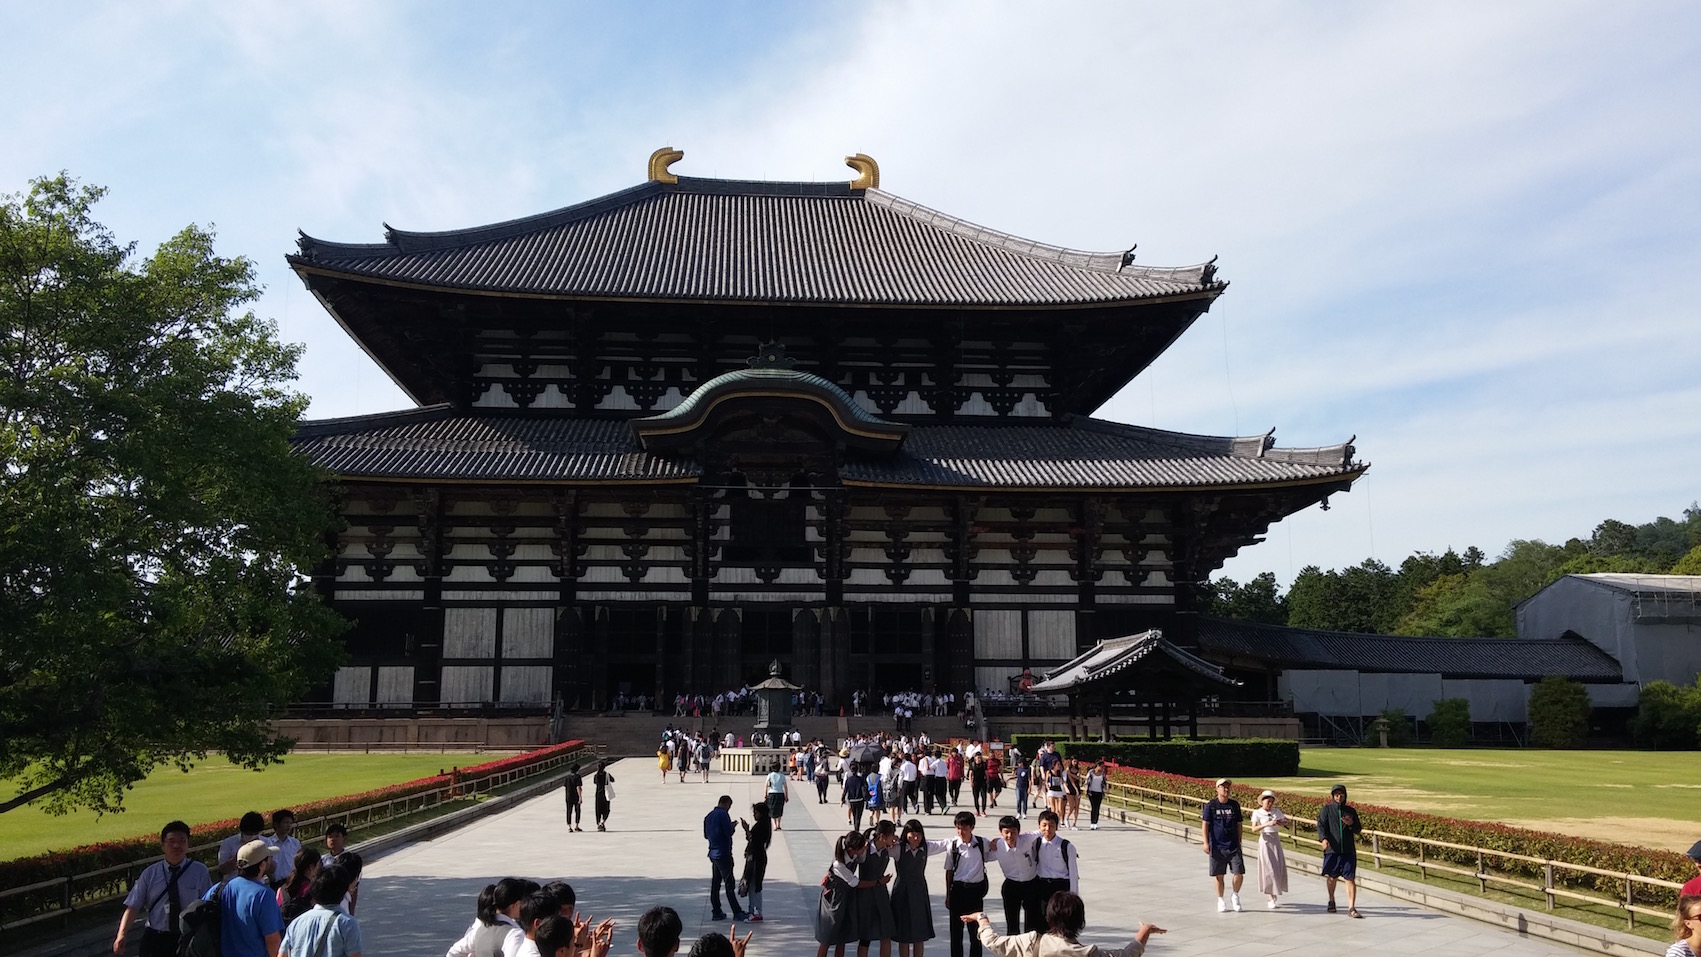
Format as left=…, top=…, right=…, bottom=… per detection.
left=0, top=739, right=585, bottom=909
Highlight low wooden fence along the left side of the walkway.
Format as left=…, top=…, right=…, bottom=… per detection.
left=0, top=745, right=599, bottom=935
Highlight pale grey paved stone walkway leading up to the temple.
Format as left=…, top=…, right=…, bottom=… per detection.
left=359, top=760, right=1582, bottom=957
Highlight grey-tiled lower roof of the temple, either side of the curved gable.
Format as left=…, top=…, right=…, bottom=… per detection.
left=296, top=405, right=1368, bottom=491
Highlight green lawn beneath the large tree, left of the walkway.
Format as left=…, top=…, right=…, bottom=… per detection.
left=0, top=751, right=509, bottom=858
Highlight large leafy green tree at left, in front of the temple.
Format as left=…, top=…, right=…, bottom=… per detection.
left=0, top=175, right=342, bottom=811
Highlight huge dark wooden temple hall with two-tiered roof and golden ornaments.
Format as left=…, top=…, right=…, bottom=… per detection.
left=289, top=150, right=1366, bottom=709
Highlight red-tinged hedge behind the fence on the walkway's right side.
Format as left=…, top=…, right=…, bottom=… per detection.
left=1111, top=767, right=1694, bottom=906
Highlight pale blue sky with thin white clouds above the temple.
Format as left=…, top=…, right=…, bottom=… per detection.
left=0, top=0, right=1701, bottom=580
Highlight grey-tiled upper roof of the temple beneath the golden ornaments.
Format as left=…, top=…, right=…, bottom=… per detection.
left=289, top=177, right=1226, bottom=308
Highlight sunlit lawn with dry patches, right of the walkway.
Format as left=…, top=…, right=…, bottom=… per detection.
left=1272, top=748, right=1701, bottom=850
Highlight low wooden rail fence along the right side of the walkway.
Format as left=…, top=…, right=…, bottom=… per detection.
left=1106, top=780, right=1682, bottom=930
